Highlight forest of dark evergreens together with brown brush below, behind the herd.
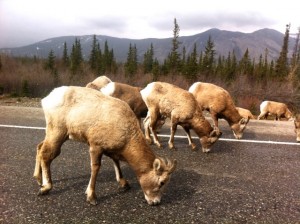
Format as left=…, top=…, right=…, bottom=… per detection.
left=0, top=19, right=300, bottom=114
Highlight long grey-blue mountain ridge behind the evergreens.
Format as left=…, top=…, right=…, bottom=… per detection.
left=0, top=28, right=295, bottom=62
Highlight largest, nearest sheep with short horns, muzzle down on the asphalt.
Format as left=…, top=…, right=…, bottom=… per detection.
left=34, top=86, right=176, bottom=205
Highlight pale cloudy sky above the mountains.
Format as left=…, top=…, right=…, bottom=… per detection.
left=0, top=0, right=300, bottom=48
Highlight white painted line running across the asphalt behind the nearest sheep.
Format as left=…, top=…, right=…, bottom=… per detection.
left=0, top=124, right=300, bottom=146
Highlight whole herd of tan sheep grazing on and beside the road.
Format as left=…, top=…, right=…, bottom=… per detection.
left=34, top=76, right=300, bottom=205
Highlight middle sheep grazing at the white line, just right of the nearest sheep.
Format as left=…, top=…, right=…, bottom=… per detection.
left=141, top=82, right=221, bottom=152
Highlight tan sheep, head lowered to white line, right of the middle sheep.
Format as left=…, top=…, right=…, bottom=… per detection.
left=189, top=82, right=249, bottom=139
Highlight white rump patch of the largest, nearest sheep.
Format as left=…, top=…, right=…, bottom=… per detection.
left=42, top=86, right=69, bottom=109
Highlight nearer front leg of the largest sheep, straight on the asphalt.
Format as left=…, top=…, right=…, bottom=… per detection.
left=85, top=146, right=102, bottom=205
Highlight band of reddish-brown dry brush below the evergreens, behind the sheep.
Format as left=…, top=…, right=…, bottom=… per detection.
left=0, top=55, right=300, bottom=115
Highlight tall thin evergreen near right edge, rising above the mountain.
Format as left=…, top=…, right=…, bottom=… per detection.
left=275, top=25, right=290, bottom=77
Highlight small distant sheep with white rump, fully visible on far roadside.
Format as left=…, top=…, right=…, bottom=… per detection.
left=257, top=100, right=292, bottom=120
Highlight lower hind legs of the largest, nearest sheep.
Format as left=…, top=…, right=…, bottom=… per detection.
left=36, top=140, right=62, bottom=195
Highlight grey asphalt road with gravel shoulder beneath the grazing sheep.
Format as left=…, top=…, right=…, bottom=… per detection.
left=0, top=106, right=300, bottom=223
